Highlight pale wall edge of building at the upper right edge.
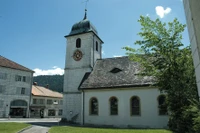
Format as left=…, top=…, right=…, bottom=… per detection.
left=183, top=0, right=200, bottom=96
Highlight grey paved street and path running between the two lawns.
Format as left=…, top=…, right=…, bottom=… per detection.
left=0, top=118, right=60, bottom=133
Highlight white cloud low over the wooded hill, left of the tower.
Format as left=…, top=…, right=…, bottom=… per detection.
left=33, top=66, right=64, bottom=76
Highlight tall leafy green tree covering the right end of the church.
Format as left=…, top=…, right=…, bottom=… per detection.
left=124, top=16, right=198, bottom=133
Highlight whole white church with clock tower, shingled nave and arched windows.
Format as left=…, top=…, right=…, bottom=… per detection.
left=63, top=12, right=169, bottom=128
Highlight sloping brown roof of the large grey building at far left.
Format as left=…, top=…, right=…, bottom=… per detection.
left=0, top=55, right=34, bottom=73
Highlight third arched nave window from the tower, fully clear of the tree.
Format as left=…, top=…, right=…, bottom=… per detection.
left=130, top=96, right=140, bottom=115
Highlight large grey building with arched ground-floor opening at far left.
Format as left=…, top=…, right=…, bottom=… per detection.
left=0, top=56, right=34, bottom=117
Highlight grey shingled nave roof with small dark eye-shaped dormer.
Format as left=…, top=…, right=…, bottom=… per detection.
left=79, top=57, right=154, bottom=89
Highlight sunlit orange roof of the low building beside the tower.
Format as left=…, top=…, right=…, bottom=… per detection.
left=32, top=85, right=63, bottom=98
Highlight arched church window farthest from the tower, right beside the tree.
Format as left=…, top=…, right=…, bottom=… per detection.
left=158, top=95, right=167, bottom=115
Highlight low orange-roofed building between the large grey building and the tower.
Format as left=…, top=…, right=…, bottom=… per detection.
left=30, top=82, right=63, bottom=118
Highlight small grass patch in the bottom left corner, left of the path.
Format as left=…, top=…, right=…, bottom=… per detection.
left=0, top=122, right=30, bottom=133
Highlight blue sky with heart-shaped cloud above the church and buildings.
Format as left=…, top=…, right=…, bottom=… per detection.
left=0, top=0, right=189, bottom=76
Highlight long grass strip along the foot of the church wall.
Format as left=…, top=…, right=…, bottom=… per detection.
left=49, top=126, right=172, bottom=133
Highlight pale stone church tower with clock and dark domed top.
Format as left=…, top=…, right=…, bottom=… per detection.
left=63, top=10, right=103, bottom=124
